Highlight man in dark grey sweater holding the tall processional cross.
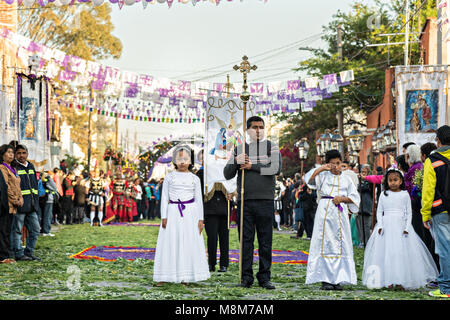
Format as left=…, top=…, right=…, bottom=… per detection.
left=223, top=116, right=281, bottom=289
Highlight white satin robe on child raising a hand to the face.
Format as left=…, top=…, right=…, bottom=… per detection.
left=305, top=171, right=360, bottom=284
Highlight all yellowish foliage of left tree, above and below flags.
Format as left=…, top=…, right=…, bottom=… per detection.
left=19, top=3, right=122, bottom=170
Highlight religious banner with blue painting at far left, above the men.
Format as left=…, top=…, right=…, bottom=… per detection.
left=17, top=74, right=50, bottom=170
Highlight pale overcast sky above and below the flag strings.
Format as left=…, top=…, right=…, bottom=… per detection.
left=98, top=0, right=372, bottom=147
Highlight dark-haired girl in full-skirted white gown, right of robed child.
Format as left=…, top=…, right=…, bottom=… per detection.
left=362, top=168, right=438, bottom=289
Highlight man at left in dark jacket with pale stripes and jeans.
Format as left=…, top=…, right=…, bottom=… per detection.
left=11, top=144, right=40, bottom=261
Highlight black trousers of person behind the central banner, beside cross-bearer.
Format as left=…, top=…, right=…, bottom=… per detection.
left=205, top=215, right=229, bottom=268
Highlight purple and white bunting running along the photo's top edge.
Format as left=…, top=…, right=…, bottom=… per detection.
left=3, top=0, right=267, bottom=9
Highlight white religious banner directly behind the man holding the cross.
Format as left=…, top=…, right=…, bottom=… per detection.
left=203, top=93, right=256, bottom=201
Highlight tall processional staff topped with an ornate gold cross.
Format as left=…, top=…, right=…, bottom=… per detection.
left=233, top=56, right=257, bottom=283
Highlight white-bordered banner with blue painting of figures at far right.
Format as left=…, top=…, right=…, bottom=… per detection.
left=395, top=66, right=448, bottom=152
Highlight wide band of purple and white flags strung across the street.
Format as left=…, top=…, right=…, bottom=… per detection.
left=0, top=28, right=354, bottom=123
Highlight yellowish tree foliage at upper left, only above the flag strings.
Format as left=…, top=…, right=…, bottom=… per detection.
left=19, top=3, right=122, bottom=60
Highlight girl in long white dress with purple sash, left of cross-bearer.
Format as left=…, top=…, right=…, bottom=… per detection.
left=153, top=146, right=210, bottom=286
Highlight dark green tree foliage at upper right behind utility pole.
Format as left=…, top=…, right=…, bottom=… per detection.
left=277, top=0, right=436, bottom=165
